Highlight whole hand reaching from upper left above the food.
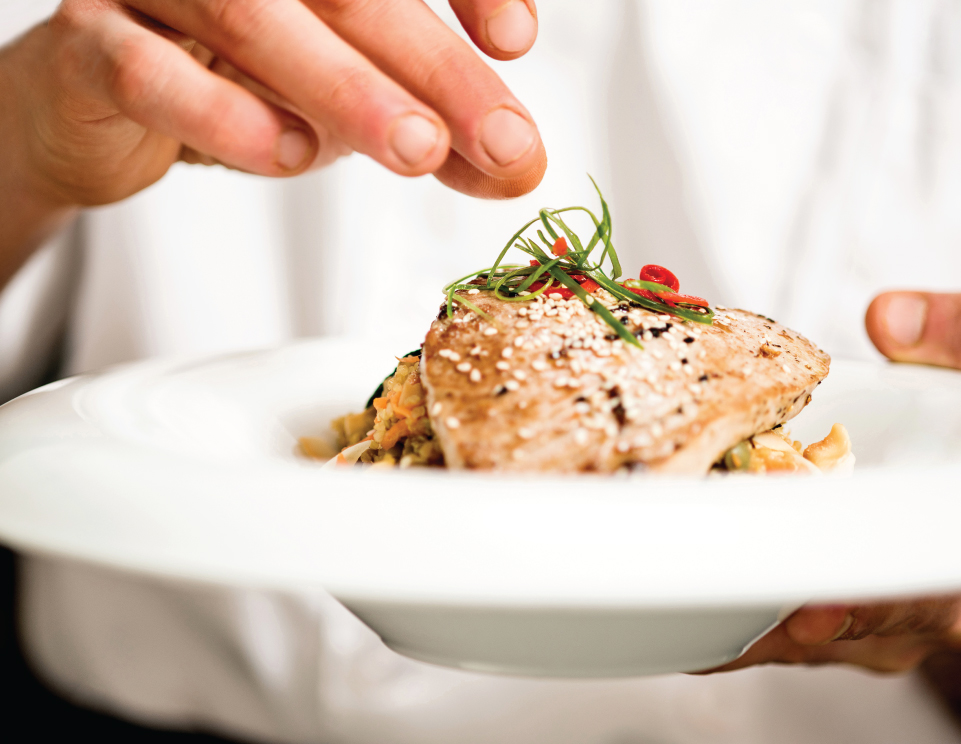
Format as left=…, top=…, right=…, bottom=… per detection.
left=0, top=0, right=547, bottom=286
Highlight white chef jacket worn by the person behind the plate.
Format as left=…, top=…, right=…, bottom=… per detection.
left=0, top=0, right=961, bottom=744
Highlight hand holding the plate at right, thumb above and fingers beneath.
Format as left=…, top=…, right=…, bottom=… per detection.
left=708, top=292, right=961, bottom=676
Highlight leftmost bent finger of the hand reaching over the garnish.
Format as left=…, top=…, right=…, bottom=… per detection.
left=80, top=12, right=317, bottom=176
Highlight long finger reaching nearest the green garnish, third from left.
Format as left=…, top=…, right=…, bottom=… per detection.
left=308, top=0, right=543, bottom=179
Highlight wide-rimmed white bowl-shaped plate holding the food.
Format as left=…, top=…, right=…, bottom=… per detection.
left=0, top=340, right=961, bottom=676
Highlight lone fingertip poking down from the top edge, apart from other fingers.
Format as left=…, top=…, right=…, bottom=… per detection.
left=450, top=0, right=537, bottom=60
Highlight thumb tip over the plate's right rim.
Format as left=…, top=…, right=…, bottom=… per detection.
left=864, top=292, right=961, bottom=369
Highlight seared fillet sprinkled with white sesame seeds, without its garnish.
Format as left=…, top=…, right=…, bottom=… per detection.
left=421, top=290, right=830, bottom=474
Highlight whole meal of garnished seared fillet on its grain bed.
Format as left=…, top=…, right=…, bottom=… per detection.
left=301, top=180, right=854, bottom=474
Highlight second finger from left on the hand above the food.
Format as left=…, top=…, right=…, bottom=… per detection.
left=130, top=0, right=450, bottom=175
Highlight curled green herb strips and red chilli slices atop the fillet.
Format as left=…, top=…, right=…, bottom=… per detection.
left=444, top=175, right=714, bottom=348
